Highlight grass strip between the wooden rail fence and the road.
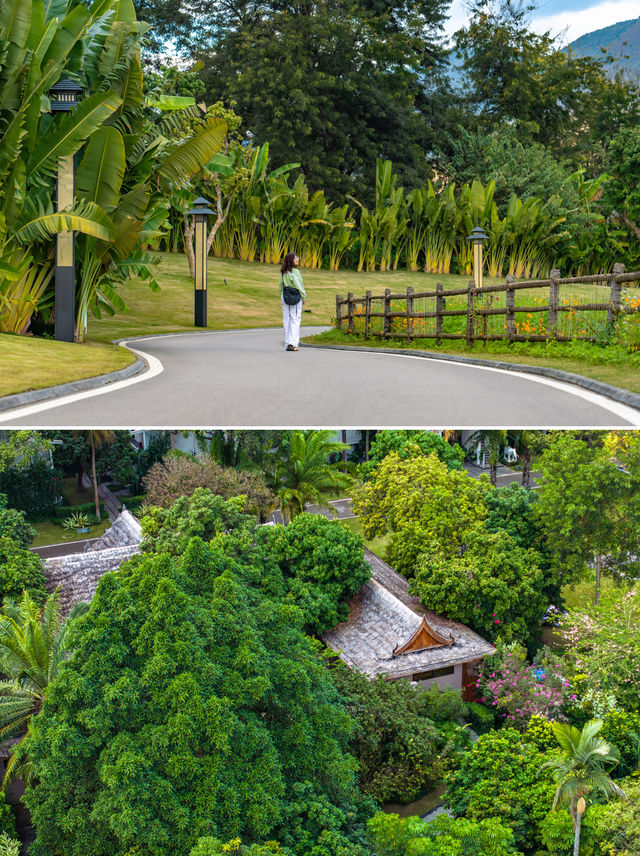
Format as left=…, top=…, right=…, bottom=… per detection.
left=302, top=330, right=640, bottom=393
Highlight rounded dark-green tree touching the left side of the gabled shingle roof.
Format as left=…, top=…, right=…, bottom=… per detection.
left=256, top=513, right=370, bottom=635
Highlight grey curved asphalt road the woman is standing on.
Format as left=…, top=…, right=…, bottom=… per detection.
left=0, top=328, right=640, bottom=428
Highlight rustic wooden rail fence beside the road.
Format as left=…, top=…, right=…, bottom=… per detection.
left=336, top=264, right=640, bottom=345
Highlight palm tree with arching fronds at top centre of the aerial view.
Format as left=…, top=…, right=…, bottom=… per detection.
left=275, top=431, right=353, bottom=522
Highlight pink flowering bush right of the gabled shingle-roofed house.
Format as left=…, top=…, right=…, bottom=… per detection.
left=476, top=644, right=571, bottom=731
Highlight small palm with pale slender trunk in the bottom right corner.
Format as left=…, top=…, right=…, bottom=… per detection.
left=541, top=719, right=626, bottom=856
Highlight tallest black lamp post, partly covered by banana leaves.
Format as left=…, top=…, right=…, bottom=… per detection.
left=49, top=80, right=82, bottom=342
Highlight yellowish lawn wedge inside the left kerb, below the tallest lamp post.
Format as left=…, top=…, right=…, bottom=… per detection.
left=0, top=333, right=135, bottom=396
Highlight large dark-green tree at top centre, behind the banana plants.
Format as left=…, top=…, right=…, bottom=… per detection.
left=200, top=0, right=446, bottom=204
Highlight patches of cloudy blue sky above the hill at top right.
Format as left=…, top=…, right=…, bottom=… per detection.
left=446, top=0, right=640, bottom=44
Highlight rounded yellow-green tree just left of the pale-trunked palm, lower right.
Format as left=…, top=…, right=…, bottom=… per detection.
left=444, top=728, right=554, bottom=850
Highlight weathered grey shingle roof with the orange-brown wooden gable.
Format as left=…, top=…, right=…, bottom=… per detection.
left=323, top=550, right=493, bottom=678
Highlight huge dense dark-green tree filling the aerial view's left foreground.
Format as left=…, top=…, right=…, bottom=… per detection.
left=25, top=538, right=370, bottom=856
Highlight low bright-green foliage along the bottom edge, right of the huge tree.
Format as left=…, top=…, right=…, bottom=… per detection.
left=368, top=812, right=521, bottom=856
